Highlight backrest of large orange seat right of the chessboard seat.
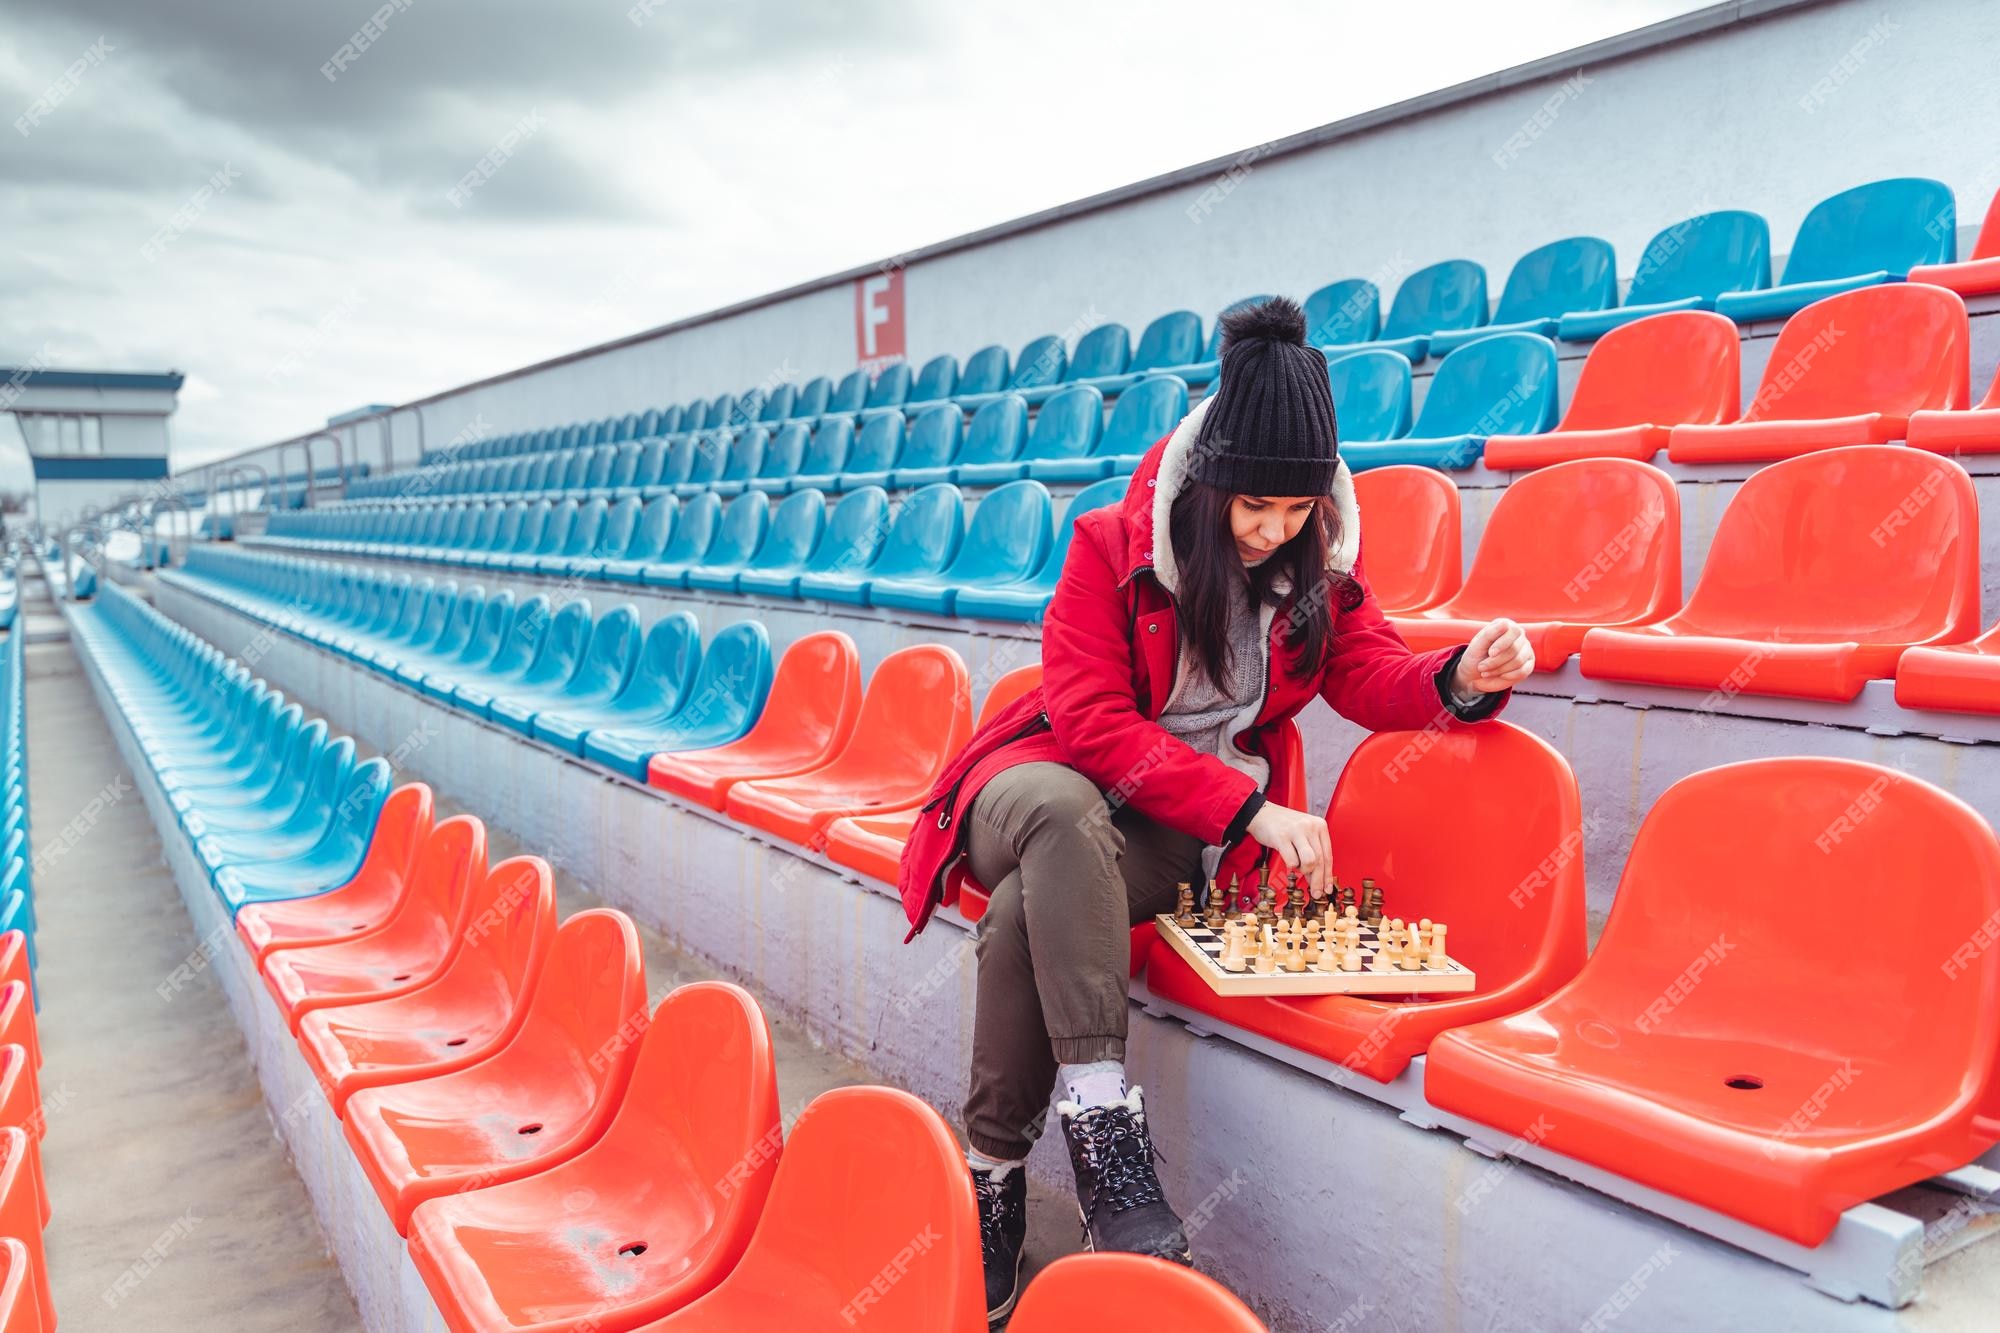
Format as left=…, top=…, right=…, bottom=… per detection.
left=1574, top=757, right=2000, bottom=1129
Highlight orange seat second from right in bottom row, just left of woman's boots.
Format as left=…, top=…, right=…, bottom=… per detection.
left=644, top=1087, right=986, bottom=1333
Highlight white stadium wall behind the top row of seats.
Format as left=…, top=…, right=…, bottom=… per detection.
left=199, top=0, right=2000, bottom=470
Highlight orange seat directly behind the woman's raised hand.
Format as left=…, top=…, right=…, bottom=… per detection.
left=1390, top=456, right=1680, bottom=671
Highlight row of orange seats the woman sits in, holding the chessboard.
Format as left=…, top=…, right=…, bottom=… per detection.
left=145, top=548, right=2000, bottom=1245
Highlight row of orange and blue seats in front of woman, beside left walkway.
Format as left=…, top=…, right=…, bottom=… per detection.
left=78, top=586, right=1262, bottom=1333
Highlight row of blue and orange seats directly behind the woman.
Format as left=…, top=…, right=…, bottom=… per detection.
left=238, top=436, right=2000, bottom=712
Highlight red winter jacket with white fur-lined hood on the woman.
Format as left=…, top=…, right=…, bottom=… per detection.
left=898, top=400, right=1506, bottom=937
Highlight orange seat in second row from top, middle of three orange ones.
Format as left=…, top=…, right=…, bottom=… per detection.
left=1666, top=282, right=1972, bottom=462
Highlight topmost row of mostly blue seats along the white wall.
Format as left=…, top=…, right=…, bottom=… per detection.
left=382, top=178, right=2000, bottom=482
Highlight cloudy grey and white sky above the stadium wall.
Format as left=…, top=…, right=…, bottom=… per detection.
left=0, top=0, right=1700, bottom=486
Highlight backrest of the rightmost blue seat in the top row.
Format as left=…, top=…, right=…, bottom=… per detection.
left=1774, top=176, right=1958, bottom=282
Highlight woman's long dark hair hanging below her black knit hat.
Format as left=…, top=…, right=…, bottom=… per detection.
left=1168, top=480, right=1362, bottom=689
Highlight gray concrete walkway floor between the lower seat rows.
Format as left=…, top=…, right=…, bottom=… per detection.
left=24, top=568, right=1080, bottom=1333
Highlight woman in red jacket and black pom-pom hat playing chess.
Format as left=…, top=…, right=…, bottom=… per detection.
left=900, top=298, right=1534, bottom=1319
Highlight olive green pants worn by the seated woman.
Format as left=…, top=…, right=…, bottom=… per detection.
left=966, top=763, right=1202, bottom=1161
